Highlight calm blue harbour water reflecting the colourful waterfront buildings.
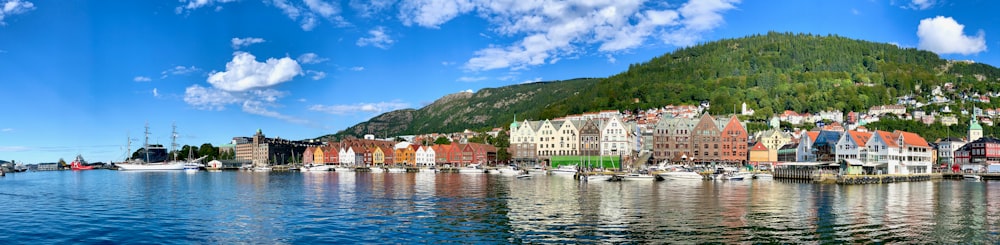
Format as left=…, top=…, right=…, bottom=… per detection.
left=0, top=170, right=1000, bottom=244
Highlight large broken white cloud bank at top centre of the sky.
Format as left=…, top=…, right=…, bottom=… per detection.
left=399, top=0, right=740, bottom=71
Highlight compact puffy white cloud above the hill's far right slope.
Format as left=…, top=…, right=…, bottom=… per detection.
left=917, top=16, right=986, bottom=55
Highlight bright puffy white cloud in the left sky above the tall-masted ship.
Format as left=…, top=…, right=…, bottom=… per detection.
left=208, top=52, right=302, bottom=92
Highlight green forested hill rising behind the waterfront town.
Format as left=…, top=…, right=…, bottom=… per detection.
left=326, top=32, right=1000, bottom=140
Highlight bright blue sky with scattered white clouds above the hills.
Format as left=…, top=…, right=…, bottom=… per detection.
left=0, top=0, right=1000, bottom=163
